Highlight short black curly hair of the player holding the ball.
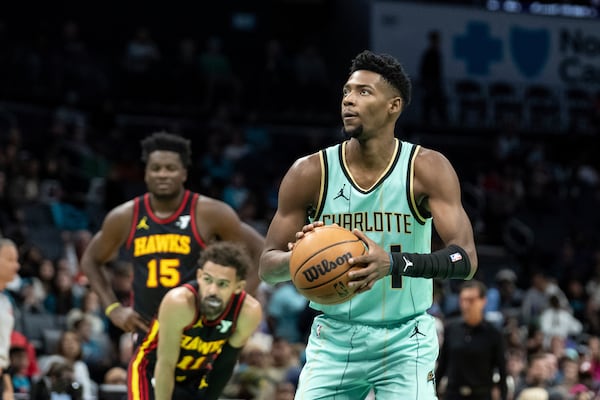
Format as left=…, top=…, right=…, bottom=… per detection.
left=350, top=50, right=412, bottom=109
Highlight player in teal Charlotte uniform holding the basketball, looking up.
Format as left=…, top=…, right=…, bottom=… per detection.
left=260, top=51, right=477, bottom=400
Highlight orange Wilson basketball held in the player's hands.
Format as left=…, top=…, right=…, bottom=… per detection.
left=290, top=225, right=367, bottom=304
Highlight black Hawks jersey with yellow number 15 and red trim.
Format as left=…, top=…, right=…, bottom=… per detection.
left=125, top=190, right=206, bottom=320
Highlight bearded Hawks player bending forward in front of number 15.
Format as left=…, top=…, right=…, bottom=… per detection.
left=129, top=242, right=262, bottom=400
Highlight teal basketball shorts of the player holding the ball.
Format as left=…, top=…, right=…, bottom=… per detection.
left=295, top=313, right=439, bottom=400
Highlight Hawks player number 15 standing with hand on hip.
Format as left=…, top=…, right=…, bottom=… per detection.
left=81, top=132, right=264, bottom=333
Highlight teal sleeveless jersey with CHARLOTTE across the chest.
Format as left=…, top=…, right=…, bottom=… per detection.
left=310, top=139, right=433, bottom=325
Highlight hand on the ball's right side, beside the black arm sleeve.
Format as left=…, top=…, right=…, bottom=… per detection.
left=348, top=229, right=390, bottom=293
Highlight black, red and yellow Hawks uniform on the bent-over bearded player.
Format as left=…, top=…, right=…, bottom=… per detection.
left=129, top=280, right=246, bottom=399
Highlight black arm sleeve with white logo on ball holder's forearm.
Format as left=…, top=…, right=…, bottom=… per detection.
left=391, top=245, right=471, bottom=279
